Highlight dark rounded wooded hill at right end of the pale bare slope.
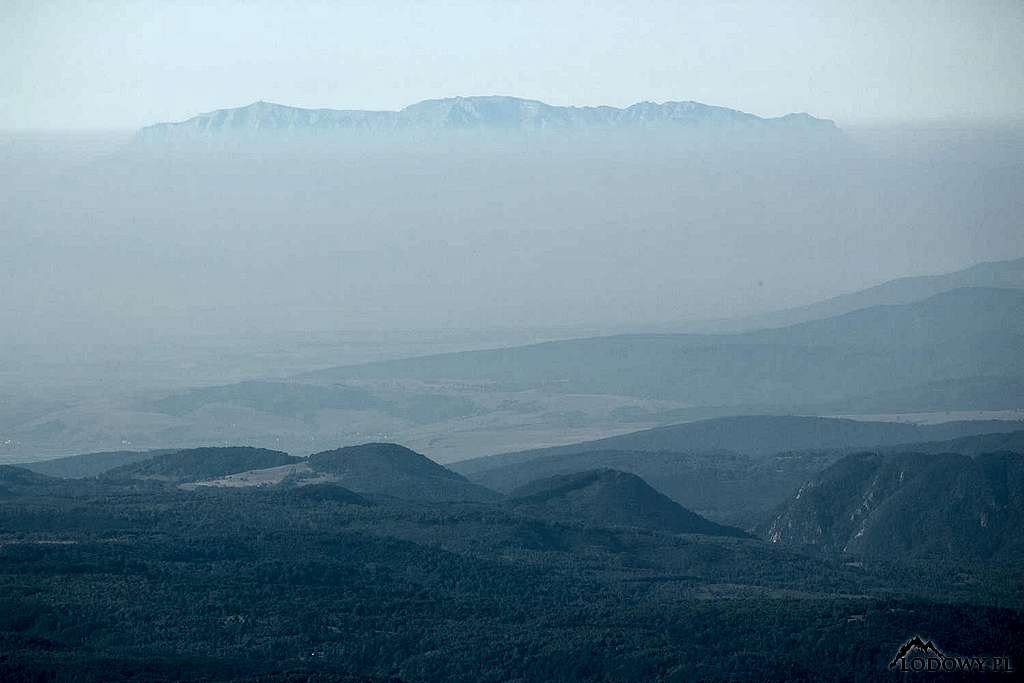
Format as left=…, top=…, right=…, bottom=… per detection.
left=309, top=443, right=499, bottom=502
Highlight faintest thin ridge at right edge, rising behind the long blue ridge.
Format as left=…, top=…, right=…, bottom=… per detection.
left=681, top=258, right=1024, bottom=333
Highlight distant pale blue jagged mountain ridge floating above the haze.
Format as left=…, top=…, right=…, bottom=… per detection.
left=138, top=95, right=839, bottom=141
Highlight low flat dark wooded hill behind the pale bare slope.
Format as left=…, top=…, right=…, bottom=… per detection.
left=103, top=446, right=302, bottom=481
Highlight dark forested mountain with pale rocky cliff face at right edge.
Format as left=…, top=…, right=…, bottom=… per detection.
left=763, top=453, right=1024, bottom=558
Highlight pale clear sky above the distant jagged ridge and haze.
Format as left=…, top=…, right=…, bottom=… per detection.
left=0, top=0, right=1024, bottom=130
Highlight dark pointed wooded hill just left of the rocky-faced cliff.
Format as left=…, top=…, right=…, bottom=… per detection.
left=509, top=469, right=746, bottom=538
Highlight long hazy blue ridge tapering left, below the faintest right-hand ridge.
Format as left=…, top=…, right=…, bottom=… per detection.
left=303, top=288, right=1024, bottom=412
